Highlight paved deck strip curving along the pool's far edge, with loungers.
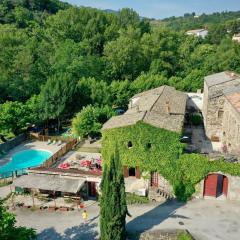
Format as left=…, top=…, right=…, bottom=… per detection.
left=0, top=141, right=63, bottom=167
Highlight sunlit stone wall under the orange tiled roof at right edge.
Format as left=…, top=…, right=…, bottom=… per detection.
left=222, top=101, right=240, bottom=156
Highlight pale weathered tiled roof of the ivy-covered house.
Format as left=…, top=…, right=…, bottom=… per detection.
left=103, top=86, right=187, bottom=132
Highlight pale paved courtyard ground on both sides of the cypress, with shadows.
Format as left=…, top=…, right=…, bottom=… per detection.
left=13, top=200, right=240, bottom=240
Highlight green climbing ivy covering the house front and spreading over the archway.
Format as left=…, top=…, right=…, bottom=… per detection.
left=102, top=121, right=240, bottom=201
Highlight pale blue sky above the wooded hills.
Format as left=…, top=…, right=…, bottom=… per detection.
left=63, top=0, right=240, bottom=19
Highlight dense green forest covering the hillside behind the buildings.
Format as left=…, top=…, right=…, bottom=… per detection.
left=0, top=0, right=240, bottom=137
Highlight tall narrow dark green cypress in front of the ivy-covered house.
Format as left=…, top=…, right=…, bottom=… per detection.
left=100, top=146, right=129, bottom=240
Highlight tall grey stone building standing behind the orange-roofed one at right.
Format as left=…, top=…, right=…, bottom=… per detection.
left=203, top=71, right=240, bottom=142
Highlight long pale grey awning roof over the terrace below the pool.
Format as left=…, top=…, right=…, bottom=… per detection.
left=13, top=174, right=86, bottom=193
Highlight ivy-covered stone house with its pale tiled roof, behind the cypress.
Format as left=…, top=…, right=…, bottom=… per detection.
left=102, top=86, right=187, bottom=200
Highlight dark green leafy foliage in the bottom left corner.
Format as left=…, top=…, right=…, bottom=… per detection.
left=0, top=200, right=36, bottom=240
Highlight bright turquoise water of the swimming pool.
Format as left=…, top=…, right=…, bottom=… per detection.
left=0, top=149, right=52, bottom=175
